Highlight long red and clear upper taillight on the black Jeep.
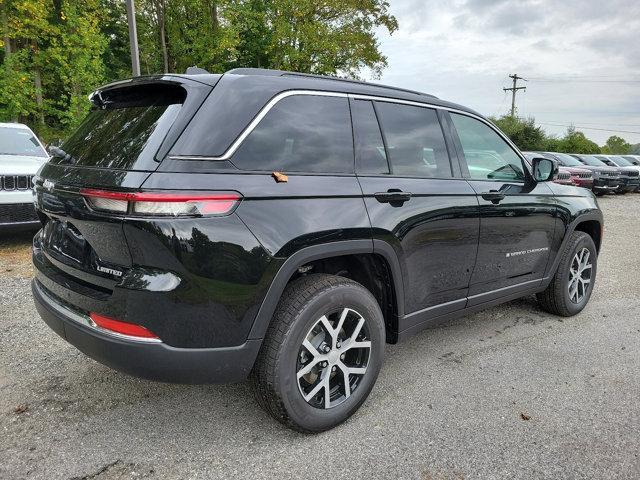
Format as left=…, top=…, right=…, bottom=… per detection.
left=80, top=188, right=242, bottom=216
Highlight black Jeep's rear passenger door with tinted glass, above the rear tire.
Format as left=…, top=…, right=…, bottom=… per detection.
left=351, top=99, right=479, bottom=330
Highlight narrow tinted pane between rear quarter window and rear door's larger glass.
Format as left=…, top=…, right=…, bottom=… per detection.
left=351, top=100, right=389, bottom=173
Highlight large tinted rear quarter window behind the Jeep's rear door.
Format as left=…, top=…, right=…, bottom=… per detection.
left=231, top=95, right=353, bottom=173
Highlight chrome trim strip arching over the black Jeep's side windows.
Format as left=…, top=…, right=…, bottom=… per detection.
left=169, top=90, right=525, bottom=167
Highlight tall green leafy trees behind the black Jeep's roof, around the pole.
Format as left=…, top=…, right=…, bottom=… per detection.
left=0, top=0, right=398, bottom=140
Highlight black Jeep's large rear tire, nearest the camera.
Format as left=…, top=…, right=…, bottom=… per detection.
left=251, top=274, right=385, bottom=433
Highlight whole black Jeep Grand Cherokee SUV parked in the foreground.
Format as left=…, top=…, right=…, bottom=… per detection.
left=28, top=69, right=602, bottom=431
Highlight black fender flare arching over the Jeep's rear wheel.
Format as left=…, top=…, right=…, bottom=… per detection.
left=248, top=239, right=404, bottom=340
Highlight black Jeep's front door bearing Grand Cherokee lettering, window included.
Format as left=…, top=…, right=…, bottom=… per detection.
left=450, top=112, right=558, bottom=306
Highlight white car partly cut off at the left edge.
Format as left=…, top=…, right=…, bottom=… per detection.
left=0, top=123, right=49, bottom=232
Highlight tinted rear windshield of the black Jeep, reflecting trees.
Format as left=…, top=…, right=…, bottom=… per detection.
left=50, top=85, right=186, bottom=170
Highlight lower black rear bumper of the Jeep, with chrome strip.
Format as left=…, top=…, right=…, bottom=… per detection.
left=31, top=280, right=261, bottom=383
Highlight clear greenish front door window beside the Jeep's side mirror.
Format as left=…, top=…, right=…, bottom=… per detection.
left=451, top=113, right=525, bottom=181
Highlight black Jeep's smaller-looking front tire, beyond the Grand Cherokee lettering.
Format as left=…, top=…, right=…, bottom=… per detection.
left=537, top=232, right=598, bottom=317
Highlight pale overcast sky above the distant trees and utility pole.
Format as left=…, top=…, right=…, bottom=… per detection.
left=364, top=0, right=640, bottom=145
